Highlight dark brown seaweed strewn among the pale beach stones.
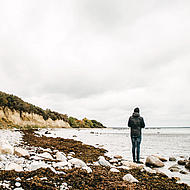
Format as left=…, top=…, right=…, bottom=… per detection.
left=0, top=130, right=190, bottom=190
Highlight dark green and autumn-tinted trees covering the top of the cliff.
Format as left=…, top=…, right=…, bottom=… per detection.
left=0, top=91, right=104, bottom=128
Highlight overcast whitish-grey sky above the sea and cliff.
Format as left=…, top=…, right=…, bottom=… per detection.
left=0, top=0, right=190, bottom=127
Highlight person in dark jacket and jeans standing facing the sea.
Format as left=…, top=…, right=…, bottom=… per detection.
left=128, top=108, right=145, bottom=163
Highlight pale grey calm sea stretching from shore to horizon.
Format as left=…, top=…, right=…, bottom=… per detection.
left=39, top=127, right=190, bottom=185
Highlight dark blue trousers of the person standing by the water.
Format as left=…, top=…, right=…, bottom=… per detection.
left=131, top=136, right=141, bottom=162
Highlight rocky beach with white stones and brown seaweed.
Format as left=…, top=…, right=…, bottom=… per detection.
left=0, top=129, right=190, bottom=190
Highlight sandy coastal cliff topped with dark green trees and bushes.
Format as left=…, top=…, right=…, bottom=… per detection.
left=0, top=91, right=104, bottom=128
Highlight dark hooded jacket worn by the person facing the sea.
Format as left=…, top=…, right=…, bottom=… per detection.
left=128, top=112, right=145, bottom=137
